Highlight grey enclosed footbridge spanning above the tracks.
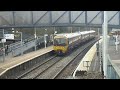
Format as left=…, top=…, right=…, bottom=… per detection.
left=0, top=11, right=120, bottom=28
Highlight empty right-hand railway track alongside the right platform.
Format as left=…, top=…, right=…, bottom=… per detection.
left=52, top=41, right=93, bottom=79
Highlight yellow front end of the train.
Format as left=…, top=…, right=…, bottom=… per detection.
left=53, top=36, right=68, bottom=55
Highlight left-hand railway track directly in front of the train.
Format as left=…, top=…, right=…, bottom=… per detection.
left=16, top=55, right=62, bottom=79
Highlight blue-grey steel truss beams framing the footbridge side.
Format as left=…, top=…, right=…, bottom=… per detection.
left=0, top=11, right=120, bottom=28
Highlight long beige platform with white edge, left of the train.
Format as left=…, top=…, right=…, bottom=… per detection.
left=0, top=46, right=53, bottom=76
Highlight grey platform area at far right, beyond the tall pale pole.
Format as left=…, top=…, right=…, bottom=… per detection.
left=107, top=37, right=120, bottom=79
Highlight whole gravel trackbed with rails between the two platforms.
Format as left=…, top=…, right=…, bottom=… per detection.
left=16, top=38, right=95, bottom=79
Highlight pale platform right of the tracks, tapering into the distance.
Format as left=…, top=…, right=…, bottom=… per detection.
left=73, top=39, right=102, bottom=79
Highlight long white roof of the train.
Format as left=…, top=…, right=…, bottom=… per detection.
left=55, top=30, right=95, bottom=38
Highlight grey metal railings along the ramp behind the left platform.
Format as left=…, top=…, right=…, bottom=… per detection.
left=0, top=36, right=53, bottom=61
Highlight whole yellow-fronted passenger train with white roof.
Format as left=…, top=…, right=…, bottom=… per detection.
left=53, top=30, right=96, bottom=55
